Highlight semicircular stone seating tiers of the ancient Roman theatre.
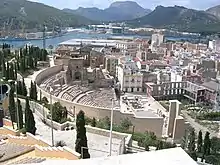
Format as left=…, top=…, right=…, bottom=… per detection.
left=40, top=75, right=114, bottom=108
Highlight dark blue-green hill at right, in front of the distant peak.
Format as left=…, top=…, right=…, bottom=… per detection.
left=127, top=6, right=220, bottom=32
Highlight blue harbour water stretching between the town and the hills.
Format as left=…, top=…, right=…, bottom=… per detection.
left=0, top=32, right=191, bottom=48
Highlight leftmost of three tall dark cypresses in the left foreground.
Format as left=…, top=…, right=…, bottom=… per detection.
left=8, top=86, right=16, bottom=122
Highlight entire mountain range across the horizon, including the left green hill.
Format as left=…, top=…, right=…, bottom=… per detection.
left=0, top=0, right=220, bottom=32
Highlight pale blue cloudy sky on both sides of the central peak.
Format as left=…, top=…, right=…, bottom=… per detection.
left=30, top=0, right=220, bottom=10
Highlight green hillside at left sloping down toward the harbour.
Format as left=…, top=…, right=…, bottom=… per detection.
left=0, top=0, right=90, bottom=29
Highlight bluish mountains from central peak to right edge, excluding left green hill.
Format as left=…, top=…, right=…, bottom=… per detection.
left=63, top=1, right=220, bottom=32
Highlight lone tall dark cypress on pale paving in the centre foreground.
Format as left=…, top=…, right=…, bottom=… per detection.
left=75, top=110, right=90, bottom=159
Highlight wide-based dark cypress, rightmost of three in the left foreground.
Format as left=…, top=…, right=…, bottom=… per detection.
left=25, top=98, right=36, bottom=135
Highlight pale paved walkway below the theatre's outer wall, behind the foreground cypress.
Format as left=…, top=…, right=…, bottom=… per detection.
left=34, top=114, right=120, bottom=158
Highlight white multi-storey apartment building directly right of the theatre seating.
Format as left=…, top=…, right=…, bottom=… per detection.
left=117, top=56, right=143, bottom=92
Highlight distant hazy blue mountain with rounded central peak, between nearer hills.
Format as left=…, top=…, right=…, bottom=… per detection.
left=64, top=1, right=151, bottom=21
